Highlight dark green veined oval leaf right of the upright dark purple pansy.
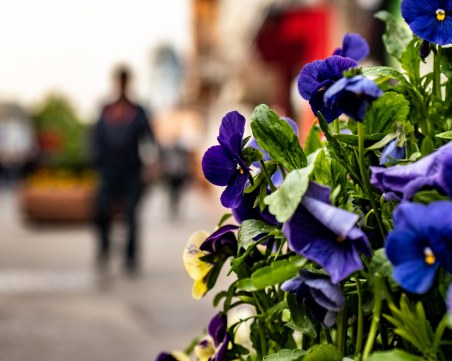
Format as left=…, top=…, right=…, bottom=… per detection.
left=251, top=104, right=307, bottom=171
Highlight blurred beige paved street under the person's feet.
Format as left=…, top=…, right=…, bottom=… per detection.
left=0, top=183, right=228, bottom=361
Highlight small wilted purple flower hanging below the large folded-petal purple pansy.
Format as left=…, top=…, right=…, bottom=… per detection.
left=281, top=270, right=345, bottom=327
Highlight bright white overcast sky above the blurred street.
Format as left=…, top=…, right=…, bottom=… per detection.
left=0, top=0, right=191, bottom=120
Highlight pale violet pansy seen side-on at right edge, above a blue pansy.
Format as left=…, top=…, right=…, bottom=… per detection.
left=370, top=142, right=452, bottom=200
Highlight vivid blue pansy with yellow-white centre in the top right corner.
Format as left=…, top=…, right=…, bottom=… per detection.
left=401, top=0, right=452, bottom=45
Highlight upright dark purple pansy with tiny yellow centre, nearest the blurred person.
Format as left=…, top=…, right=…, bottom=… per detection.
left=202, top=111, right=249, bottom=208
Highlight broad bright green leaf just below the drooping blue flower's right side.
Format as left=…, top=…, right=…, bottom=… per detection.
left=364, top=92, right=410, bottom=134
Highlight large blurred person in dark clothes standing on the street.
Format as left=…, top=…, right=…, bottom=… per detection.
left=92, top=67, right=155, bottom=274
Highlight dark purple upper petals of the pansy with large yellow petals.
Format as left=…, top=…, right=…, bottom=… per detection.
left=199, top=224, right=239, bottom=256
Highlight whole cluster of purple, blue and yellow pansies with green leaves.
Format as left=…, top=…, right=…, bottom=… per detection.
left=159, top=0, right=452, bottom=361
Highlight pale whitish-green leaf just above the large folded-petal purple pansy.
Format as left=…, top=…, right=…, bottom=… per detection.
left=264, top=164, right=314, bottom=223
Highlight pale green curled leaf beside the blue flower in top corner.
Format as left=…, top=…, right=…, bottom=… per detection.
left=375, top=11, right=413, bottom=61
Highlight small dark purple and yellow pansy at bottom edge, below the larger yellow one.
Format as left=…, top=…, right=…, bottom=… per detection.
left=195, top=314, right=229, bottom=361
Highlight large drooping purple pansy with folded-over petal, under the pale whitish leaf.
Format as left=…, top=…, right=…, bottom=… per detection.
left=283, top=182, right=371, bottom=283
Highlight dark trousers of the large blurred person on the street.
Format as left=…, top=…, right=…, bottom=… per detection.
left=95, top=168, right=142, bottom=271
